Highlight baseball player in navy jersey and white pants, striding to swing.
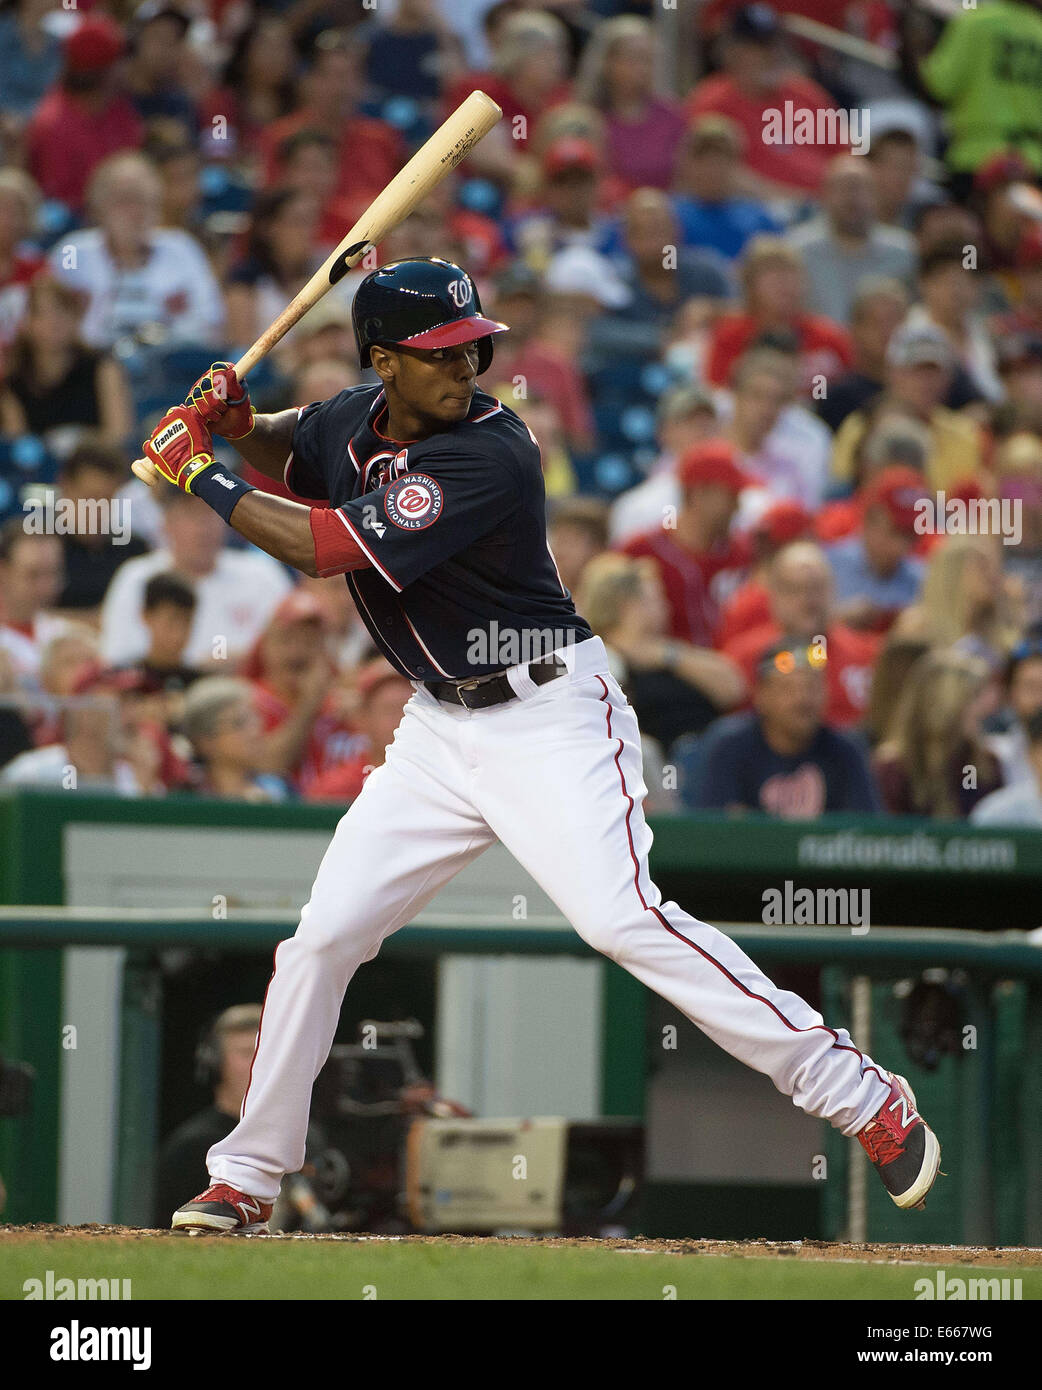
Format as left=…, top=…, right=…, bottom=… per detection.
left=134, top=259, right=941, bottom=1232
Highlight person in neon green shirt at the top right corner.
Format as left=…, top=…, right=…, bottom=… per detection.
left=921, top=0, right=1042, bottom=184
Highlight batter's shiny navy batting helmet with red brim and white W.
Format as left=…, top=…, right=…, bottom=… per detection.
left=352, top=256, right=508, bottom=373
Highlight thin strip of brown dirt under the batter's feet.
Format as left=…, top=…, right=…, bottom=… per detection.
left=0, top=1222, right=1042, bottom=1268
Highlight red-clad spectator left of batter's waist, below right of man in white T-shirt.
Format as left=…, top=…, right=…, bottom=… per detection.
left=242, top=589, right=357, bottom=794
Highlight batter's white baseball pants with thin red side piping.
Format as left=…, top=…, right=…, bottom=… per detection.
left=207, top=638, right=889, bottom=1201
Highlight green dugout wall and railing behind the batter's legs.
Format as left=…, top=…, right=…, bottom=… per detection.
left=0, top=792, right=1042, bottom=1244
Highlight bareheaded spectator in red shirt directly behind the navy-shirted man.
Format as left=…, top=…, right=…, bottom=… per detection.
left=722, top=541, right=879, bottom=728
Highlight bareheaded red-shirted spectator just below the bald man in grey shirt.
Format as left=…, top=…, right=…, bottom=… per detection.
left=706, top=235, right=854, bottom=392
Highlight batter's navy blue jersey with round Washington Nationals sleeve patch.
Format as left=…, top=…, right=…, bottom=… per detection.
left=286, top=386, right=592, bottom=681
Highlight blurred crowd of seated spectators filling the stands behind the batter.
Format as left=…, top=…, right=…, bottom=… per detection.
left=0, top=0, right=1042, bottom=824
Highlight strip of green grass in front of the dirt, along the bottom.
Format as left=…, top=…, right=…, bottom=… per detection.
left=0, top=1227, right=1042, bottom=1301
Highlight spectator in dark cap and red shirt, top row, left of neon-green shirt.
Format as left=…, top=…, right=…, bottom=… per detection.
left=688, top=4, right=845, bottom=197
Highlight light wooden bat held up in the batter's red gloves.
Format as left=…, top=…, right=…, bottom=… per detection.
left=131, top=92, right=503, bottom=488
